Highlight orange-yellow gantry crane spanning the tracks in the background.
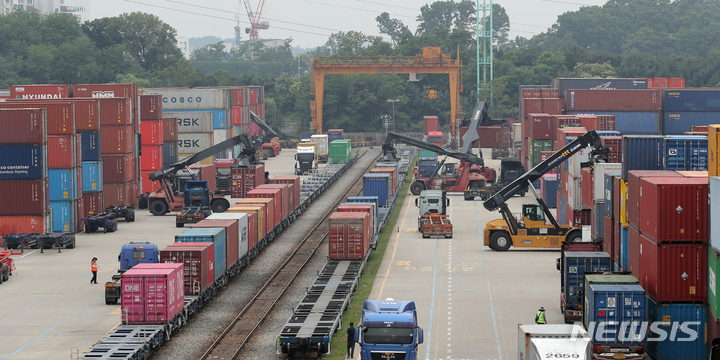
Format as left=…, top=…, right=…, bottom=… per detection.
left=310, top=46, right=463, bottom=148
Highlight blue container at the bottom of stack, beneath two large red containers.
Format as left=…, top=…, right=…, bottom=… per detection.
left=648, top=298, right=710, bottom=360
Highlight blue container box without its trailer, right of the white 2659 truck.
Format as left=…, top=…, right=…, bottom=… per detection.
left=584, top=284, right=647, bottom=346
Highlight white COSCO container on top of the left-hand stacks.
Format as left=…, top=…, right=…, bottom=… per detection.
left=140, top=89, right=230, bottom=110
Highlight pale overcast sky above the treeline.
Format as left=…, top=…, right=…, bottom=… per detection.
left=89, top=0, right=605, bottom=47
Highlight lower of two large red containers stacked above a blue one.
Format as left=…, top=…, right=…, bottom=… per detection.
left=638, top=235, right=708, bottom=303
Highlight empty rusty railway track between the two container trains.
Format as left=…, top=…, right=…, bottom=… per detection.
left=200, top=152, right=374, bottom=360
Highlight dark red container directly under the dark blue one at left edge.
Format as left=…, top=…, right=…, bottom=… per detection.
left=0, top=179, right=50, bottom=215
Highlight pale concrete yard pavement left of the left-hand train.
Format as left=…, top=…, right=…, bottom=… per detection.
left=0, top=149, right=295, bottom=359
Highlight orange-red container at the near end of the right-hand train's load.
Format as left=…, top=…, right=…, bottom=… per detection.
left=328, top=212, right=372, bottom=260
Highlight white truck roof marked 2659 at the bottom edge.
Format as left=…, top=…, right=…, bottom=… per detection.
left=518, top=324, right=592, bottom=360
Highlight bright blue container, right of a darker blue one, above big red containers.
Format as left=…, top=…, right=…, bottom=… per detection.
left=665, top=135, right=708, bottom=171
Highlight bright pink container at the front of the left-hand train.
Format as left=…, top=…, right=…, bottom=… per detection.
left=120, top=263, right=185, bottom=325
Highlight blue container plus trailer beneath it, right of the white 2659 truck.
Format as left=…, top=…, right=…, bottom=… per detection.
left=584, top=284, right=648, bottom=360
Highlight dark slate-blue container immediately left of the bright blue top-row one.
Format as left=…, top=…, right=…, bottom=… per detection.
left=622, top=135, right=665, bottom=181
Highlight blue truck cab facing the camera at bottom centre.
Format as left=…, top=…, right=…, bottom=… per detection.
left=355, top=299, right=423, bottom=360
